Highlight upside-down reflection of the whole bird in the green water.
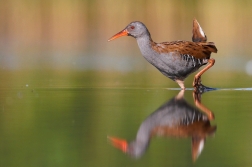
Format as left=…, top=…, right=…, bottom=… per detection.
left=108, top=90, right=216, bottom=160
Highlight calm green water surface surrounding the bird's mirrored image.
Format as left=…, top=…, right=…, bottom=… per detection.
left=0, top=71, right=252, bottom=167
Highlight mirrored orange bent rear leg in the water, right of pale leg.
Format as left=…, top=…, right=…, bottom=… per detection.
left=193, top=92, right=214, bottom=120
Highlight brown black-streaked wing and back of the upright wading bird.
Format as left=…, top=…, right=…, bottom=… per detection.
left=151, top=41, right=217, bottom=59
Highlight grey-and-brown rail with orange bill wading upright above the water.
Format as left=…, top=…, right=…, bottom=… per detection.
left=108, top=19, right=217, bottom=90
